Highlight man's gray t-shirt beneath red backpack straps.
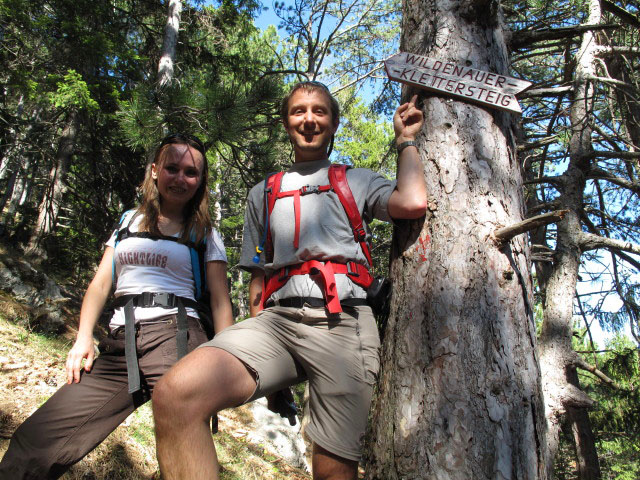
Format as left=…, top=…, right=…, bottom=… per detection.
left=239, top=160, right=395, bottom=300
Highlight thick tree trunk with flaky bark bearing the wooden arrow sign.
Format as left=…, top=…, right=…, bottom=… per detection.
left=366, top=0, right=548, bottom=480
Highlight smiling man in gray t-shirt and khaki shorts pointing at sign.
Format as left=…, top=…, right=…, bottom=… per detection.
left=153, top=82, right=426, bottom=480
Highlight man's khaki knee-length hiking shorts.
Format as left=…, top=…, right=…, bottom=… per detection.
left=202, top=306, right=380, bottom=460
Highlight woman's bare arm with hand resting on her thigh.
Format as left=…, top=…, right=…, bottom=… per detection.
left=66, top=247, right=114, bottom=383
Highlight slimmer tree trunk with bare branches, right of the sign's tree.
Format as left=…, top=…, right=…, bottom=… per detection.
left=540, top=0, right=601, bottom=480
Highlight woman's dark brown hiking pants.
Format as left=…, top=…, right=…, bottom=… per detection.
left=0, top=315, right=207, bottom=480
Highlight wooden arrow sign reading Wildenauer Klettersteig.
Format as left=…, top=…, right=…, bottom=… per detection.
left=384, top=53, right=533, bottom=114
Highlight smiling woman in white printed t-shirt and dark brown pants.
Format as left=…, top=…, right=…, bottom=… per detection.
left=0, top=134, right=232, bottom=480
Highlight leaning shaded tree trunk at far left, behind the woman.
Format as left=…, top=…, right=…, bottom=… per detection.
left=28, top=112, right=77, bottom=253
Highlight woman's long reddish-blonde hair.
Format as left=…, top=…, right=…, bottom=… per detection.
left=138, top=133, right=211, bottom=245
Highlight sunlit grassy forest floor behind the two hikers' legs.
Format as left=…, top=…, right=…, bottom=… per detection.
left=0, top=294, right=311, bottom=480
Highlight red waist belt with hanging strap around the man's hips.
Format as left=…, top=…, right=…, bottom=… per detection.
left=262, top=260, right=373, bottom=313
